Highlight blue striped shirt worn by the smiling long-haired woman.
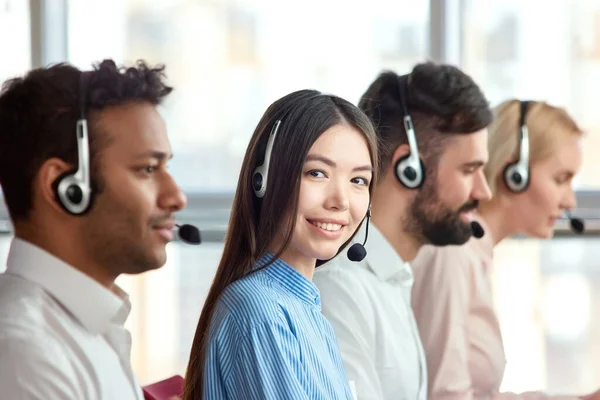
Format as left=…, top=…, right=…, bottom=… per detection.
left=203, top=254, right=352, bottom=400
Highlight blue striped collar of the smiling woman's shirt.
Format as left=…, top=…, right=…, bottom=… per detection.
left=257, top=253, right=321, bottom=308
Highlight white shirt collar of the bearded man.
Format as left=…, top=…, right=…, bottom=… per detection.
left=355, top=223, right=414, bottom=286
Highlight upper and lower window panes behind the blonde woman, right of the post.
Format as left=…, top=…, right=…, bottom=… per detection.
left=461, top=0, right=600, bottom=394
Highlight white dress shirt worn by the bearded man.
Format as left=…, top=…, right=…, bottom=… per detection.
left=313, top=224, right=427, bottom=400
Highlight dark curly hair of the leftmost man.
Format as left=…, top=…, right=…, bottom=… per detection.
left=0, top=59, right=173, bottom=221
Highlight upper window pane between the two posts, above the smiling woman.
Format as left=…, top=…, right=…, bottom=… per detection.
left=68, top=0, right=428, bottom=193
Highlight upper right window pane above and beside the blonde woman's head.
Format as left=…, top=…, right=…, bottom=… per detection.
left=463, top=0, right=600, bottom=190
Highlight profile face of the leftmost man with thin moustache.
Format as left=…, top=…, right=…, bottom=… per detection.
left=81, top=102, right=186, bottom=274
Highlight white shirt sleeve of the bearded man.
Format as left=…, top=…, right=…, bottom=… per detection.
left=314, top=270, right=383, bottom=400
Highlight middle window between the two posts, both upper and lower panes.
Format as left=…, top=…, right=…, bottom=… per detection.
left=68, top=0, right=429, bottom=383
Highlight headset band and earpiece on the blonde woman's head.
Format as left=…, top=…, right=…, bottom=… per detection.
left=504, top=101, right=530, bottom=193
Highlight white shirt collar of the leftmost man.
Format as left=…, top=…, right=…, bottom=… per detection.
left=6, top=238, right=131, bottom=334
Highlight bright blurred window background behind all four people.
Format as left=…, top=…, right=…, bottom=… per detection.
left=0, top=0, right=600, bottom=394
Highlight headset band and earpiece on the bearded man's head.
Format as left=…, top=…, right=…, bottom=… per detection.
left=395, top=75, right=425, bottom=189
